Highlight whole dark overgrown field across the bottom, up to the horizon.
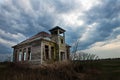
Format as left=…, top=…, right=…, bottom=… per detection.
left=0, top=59, right=120, bottom=80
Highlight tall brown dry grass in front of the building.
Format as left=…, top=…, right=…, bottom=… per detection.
left=0, top=62, right=80, bottom=80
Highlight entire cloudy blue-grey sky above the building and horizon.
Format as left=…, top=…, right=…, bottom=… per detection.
left=0, top=0, right=120, bottom=58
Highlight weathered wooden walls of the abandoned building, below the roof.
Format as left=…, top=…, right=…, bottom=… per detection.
left=14, top=37, right=69, bottom=63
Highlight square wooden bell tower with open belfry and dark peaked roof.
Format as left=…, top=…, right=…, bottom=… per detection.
left=49, top=26, right=66, bottom=61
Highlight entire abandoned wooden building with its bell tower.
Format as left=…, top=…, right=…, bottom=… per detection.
left=12, top=26, right=70, bottom=64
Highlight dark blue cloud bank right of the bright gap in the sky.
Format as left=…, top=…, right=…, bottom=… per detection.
left=80, top=0, right=120, bottom=49
